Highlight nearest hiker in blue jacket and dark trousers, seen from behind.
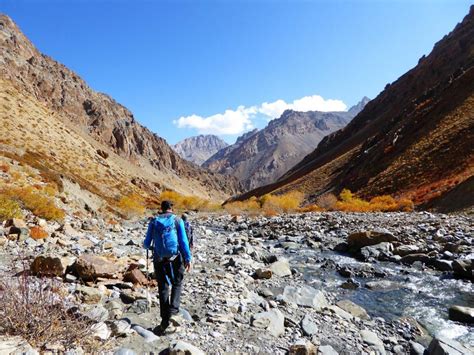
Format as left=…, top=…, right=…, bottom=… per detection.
left=143, top=201, right=192, bottom=334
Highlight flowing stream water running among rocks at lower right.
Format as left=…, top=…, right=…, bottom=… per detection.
left=289, top=249, right=474, bottom=347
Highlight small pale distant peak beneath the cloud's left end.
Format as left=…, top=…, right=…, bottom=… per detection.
left=173, top=134, right=228, bottom=165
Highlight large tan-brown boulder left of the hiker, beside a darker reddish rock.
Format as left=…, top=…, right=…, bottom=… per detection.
left=72, top=254, right=120, bottom=281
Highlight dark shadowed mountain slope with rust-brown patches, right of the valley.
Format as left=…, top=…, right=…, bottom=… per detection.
left=235, top=6, right=474, bottom=210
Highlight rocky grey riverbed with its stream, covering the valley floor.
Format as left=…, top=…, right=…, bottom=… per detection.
left=0, top=212, right=474, bottom=354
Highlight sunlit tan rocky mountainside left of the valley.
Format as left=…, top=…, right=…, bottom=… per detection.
left=0, top=15, right=239, bottom=206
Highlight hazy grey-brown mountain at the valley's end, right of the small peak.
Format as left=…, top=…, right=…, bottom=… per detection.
left=203, top=98, right=368, bottom=188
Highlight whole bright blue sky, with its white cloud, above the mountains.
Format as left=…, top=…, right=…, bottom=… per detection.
left=0, top=0, right=470, bottom=143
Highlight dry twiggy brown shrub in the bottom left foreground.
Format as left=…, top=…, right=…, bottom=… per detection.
left=0, top=272, right=97, bottom=352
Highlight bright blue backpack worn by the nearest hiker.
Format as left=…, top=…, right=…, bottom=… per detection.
left=152, top=213, right=179, bottom=259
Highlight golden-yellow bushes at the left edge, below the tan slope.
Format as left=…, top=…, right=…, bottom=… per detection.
left=1, top=186, right=64, bottom=220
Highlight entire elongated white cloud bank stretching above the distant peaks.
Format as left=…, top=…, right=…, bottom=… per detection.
left=173, top=95, right=347, bottom=135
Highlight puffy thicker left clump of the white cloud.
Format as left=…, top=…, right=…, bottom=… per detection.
left=173, top=106, right=257, bottom=135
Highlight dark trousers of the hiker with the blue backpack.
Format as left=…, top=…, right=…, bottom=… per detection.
left=154, top=255, right=184, bottom=326
